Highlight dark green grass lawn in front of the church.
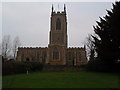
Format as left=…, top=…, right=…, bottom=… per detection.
left=2, top=72, right=120, bottom=88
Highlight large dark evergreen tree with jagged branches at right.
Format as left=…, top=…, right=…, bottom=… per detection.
left=93, top=1, right=120, bottom=66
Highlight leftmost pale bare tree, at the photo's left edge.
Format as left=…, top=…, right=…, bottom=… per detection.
left=2, top=35, right=11, bottom=58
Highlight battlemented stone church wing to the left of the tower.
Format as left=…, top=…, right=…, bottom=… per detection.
left=17, top=47, right=48, bottom=63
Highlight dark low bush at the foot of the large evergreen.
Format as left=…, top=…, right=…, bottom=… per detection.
left=86, top=59, right=120, bottom=72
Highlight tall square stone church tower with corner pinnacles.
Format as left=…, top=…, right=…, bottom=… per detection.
left=48, top=5, right=67, bottom=65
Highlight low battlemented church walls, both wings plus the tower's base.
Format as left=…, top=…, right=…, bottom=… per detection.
left=17, top=45, right=87, bottom=66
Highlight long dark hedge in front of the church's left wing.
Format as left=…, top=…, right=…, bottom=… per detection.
left=2, top=61, right=43, bottom=75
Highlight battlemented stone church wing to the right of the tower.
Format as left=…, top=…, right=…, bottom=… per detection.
left=66, top=47, right=87, bottom=66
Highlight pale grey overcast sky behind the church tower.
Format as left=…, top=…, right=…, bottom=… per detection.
left=2, top=2, right=112, bottom=47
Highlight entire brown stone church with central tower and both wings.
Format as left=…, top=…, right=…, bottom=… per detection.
left=17, top=5, right=87, bottom=66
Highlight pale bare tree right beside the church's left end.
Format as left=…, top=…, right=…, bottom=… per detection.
left=12, top=36, right=21, bottom=59
